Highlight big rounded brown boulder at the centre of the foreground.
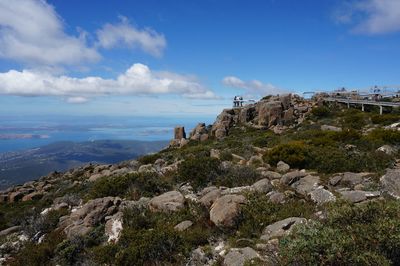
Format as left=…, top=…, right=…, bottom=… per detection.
left=210, top=195, right=246, bottom=227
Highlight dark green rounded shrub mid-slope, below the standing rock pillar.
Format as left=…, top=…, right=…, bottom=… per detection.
left=176, top=156, right=221, bottom=189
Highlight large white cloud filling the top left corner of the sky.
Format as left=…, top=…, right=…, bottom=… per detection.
left=0, top=0, right=100, bottom=66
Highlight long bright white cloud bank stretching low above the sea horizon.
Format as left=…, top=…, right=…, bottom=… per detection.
left=0, top=64, right=217, bottom=103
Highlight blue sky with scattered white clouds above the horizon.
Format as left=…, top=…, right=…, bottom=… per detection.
left=0, top=0, right=400, bottom=117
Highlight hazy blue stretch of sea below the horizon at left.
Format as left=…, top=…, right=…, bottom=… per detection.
left=0, top=116, right=215, bottom=153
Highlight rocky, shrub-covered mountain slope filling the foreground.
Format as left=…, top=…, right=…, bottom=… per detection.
left=0, top=94, right=400, bottom=266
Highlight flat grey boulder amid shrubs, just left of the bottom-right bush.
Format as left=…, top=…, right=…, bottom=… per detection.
left=260, top=217, right=307, bottom=241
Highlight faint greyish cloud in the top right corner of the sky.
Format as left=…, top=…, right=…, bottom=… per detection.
left=334, top=0, right=400, bottom=35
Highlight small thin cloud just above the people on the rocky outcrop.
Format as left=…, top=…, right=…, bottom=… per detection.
left=222, top=76, right=287, bottom=96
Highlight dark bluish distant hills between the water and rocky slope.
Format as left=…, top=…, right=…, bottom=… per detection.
left=0, top=140, right=168, bottom=189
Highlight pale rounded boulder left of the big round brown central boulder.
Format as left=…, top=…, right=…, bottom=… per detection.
left=149, top=191, right=185, bottom=212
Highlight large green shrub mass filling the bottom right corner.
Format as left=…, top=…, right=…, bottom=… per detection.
left=280, top=201, right=400, bottom=265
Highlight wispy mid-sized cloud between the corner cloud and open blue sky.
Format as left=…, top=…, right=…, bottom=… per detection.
left=97, top=17, right=167, bottom=56
